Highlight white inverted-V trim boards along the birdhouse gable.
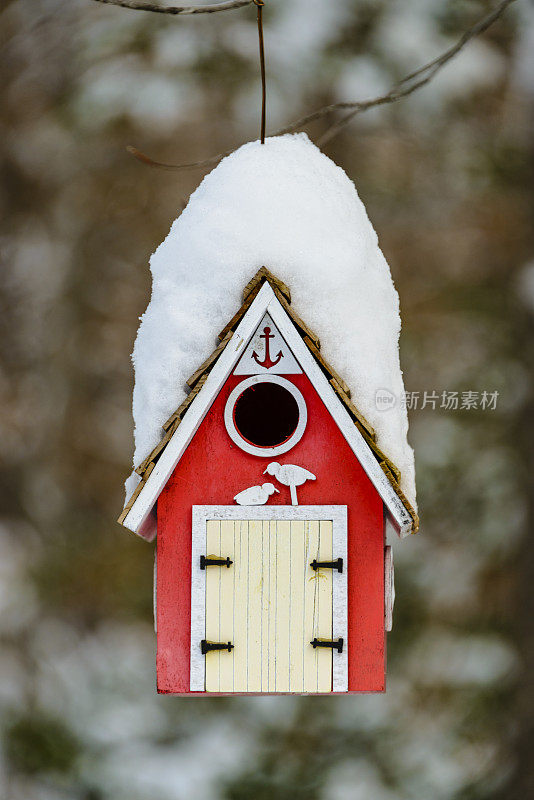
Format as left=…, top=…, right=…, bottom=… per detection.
left=122, top=281, right=412, bottom=536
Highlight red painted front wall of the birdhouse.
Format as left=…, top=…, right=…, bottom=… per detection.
left=157, top=375, right=385, bottom=694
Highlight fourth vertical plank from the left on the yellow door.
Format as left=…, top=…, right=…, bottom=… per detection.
left=247, top=520, right=263, bottom=692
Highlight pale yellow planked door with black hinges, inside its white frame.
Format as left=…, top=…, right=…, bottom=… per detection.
left=205, top=519, right=333, bottom=692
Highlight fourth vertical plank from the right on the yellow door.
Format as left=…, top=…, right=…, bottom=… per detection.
left=273, top=520, right=291, bottom=692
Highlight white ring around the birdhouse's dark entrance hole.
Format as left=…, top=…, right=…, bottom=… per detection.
left=224, top=374, right=308, bottom=458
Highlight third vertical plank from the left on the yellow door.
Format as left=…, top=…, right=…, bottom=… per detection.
left=233, top=520, right=249, bottom=692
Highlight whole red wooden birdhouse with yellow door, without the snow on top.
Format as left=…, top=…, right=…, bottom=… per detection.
left=119, top=268, right=418, bottom=695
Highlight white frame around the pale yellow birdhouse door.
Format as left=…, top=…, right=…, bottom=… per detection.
left=190, top=506, right=349, bottom=692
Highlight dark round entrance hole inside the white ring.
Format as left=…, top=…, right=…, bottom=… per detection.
left=234, top=382, right=299, bottom=447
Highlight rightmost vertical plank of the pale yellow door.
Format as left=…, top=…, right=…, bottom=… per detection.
left=315, top=521, right=337, bottom=692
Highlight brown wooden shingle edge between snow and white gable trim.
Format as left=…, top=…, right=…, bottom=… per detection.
left=123, top=267, right=419, bottom=533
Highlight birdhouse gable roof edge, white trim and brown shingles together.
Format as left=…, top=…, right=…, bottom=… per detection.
left=119, top=267, right=419, bottom=536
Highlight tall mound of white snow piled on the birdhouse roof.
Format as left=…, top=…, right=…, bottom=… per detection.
left=128, top=134, right=415, bottom=502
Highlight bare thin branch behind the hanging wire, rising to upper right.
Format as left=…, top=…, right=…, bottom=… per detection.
left=125, top=0, right=516, bottom=169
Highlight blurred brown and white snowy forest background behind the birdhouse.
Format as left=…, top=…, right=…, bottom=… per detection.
left=0, top=0, right=534, bottom=800
